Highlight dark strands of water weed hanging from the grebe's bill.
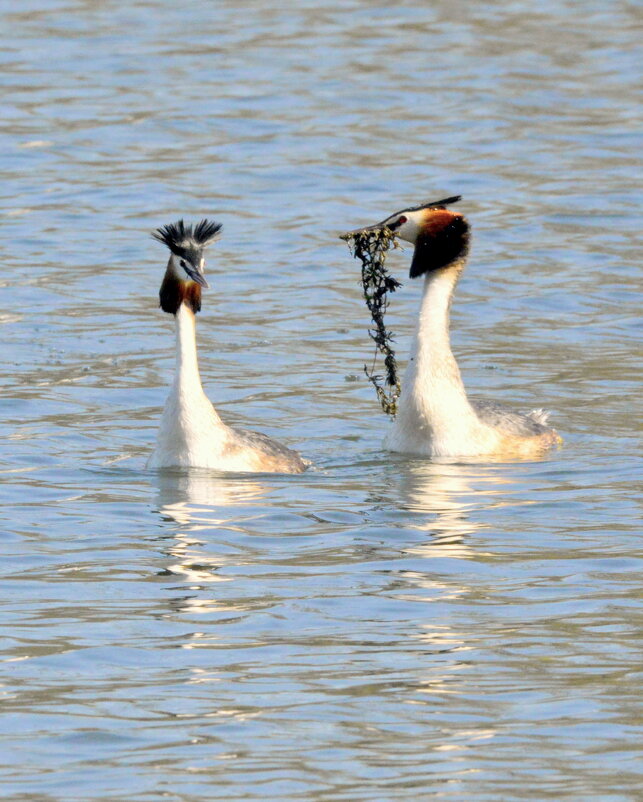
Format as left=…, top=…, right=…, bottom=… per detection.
left=341, top=226, right=401, bottom=417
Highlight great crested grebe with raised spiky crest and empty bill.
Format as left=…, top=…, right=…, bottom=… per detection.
left=147, top=220, right=307, bottom=473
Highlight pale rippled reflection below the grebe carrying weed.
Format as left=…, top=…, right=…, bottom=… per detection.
left=389, top=460, right=515, bottom=724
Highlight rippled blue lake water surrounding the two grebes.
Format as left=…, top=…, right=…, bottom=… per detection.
left=0, top=0, right=641, bottom=802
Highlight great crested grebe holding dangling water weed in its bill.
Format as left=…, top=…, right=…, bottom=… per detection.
left=354, top=196, right=561, bottom=457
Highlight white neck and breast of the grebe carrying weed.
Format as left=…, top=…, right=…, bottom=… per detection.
left=395, top=263, right=486, bottom=453
